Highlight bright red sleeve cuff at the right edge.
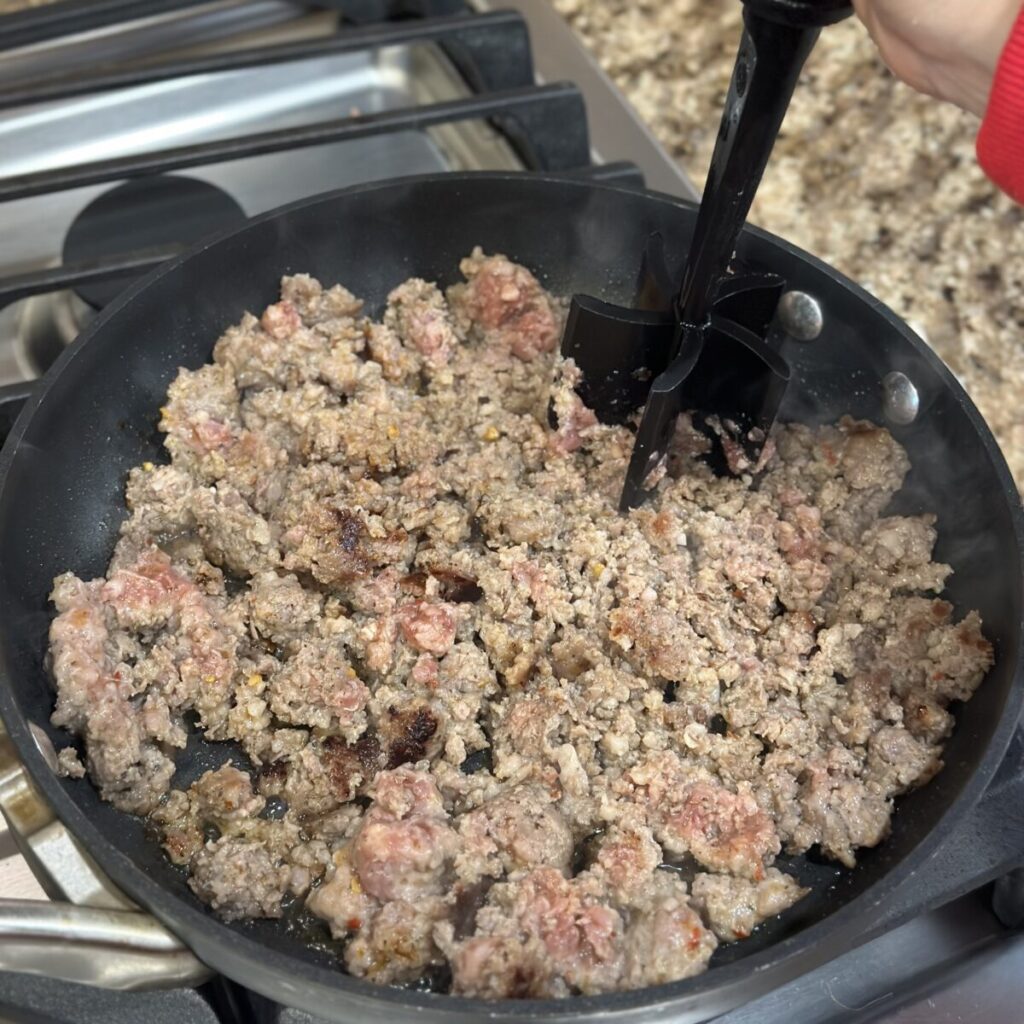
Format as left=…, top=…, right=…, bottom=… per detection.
left=977, top=8, right=1024, bottom=204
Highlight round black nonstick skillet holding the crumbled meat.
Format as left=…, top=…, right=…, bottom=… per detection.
left=0, top=174, right=1024, bottom=1022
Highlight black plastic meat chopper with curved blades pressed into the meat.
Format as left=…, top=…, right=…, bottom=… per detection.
left=562, top=0, right=851, bottom=511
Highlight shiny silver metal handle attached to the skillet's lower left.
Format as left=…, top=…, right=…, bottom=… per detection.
left=0, top=725, right=213, bottom=989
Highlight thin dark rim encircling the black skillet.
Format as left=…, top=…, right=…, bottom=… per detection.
left=0, top=171, right=1024, bottom=1020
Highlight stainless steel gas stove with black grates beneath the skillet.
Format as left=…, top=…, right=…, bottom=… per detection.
left=0, top=0, right=1024, bottom=1024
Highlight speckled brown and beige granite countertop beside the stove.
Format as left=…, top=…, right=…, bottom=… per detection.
left=554, top=0, right=1024, bottom=487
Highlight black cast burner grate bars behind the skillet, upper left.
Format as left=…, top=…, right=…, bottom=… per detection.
left=0, top=0, right=643, bottom=321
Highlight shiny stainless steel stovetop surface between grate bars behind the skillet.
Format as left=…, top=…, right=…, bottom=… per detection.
left=0, top=0, right=696, bottom=385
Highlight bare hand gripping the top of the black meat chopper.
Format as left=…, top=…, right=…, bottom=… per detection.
left=853, top=0, right=1022, bottom=117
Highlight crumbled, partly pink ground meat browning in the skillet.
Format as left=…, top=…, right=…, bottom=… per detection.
left=50, top=251, right=992, bottom=998
